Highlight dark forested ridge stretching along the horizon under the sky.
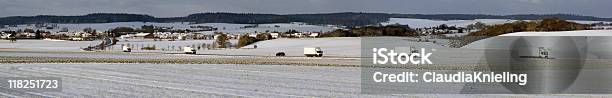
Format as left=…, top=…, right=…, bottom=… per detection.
left=0, top=12, right=612, bottom=26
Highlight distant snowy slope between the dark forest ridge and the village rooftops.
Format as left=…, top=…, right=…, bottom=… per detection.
left=0, top=22, right=336, bottom=33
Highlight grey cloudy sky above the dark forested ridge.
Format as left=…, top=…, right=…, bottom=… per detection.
left=0, top=0, right=612, bottom=17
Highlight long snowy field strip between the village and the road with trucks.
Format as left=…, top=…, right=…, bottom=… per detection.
left=0, top=37, right=464, bottom=57
